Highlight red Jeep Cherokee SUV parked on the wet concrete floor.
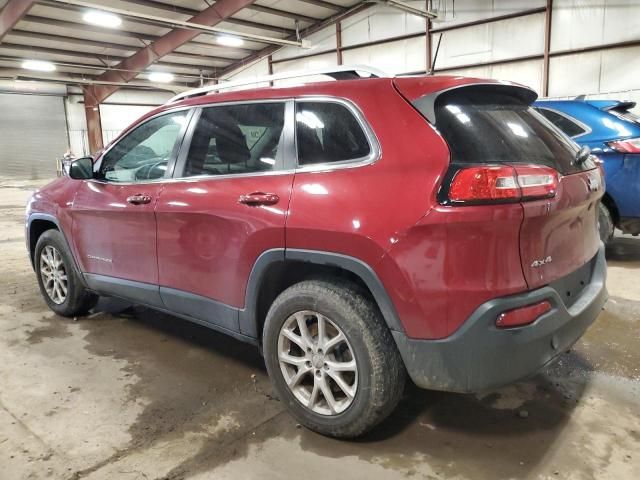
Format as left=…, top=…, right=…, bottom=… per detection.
left=26, top=68, right=607, bottom=437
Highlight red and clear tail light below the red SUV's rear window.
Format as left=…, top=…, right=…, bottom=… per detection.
left=449, top=165, right=559, bottom=204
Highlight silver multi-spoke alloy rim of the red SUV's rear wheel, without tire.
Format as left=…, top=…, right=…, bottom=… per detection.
left=278, top=310, right=358, bottom=415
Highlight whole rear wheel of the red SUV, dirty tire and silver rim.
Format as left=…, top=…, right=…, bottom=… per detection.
left=263, top=280, right=406, bottom=438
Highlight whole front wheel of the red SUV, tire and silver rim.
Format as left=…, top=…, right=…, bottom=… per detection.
left=33, top=230, right=98, bottom=317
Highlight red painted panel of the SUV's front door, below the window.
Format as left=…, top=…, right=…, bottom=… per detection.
left=69, top=180, right=162, bottom=284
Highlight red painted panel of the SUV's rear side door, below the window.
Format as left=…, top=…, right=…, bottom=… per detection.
left=156, top=173, right=293, bottom=308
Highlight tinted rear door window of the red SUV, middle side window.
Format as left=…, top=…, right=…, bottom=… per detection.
left=184, top=103, right=284, bottom=176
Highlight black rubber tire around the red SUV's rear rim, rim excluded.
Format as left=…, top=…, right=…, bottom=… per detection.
left=263, top=280, right=406, bottom=438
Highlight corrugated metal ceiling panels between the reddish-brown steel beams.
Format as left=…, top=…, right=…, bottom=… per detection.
left=0, top=0, right=362, bottom=84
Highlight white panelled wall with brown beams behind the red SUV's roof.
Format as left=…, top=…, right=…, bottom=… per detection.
left=222, top=0, right=640, bottom=112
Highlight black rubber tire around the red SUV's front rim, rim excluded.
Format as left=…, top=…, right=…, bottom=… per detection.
left=33, top=229, right=98, bottom=317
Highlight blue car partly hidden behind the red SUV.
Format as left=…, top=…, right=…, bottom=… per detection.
left=534, top=97, right=640, bottom=243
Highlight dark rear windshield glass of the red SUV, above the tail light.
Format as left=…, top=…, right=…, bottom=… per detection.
left=424, top=86, right=595, bottom=174
